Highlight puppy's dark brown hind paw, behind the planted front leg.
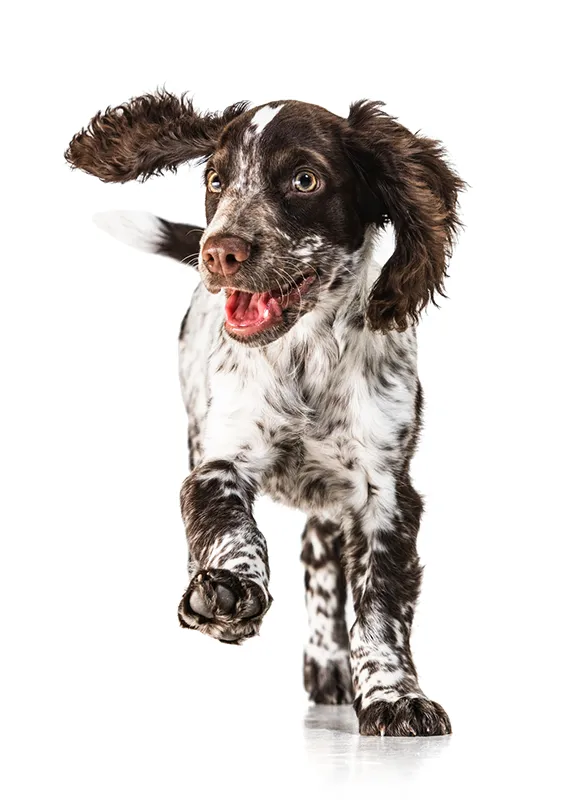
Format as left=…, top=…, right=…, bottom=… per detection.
left=303, top=648, right=354, bottom=705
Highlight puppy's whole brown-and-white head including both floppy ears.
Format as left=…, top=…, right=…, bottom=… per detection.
left=66, top=92, right=463, bottom=345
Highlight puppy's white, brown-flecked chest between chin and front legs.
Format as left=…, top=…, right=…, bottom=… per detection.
left=204, top=318, right=416, bottom=511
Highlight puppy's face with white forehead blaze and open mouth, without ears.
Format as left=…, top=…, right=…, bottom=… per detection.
left=199, top=102, right=366, bottom=345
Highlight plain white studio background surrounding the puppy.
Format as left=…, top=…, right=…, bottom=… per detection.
left=0, top=2, right=563, bottom=800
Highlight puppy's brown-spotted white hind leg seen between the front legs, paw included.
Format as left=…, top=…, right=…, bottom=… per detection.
left=301, top=517, right=353, bottom=705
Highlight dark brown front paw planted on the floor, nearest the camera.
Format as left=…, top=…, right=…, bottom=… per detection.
left=358, top=695, right=452, bottom=736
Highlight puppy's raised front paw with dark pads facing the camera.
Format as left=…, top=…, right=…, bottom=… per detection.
left=178, top=569, right=272, bottom=644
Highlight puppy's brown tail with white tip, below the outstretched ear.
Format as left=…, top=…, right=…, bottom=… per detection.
left=93, top=211, right=203, bottom=265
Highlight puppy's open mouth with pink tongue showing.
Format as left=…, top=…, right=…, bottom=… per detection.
left=225, top=275, right=315, bottom=336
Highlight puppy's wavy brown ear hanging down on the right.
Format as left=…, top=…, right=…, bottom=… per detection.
left=346, top=100, right=464, bottom=331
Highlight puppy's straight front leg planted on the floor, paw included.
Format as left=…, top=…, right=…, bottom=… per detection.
left=343, top=473, right=451, bottom=736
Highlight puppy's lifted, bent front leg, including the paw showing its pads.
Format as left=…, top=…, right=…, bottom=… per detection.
left=178, top=459, right=271, bottom=643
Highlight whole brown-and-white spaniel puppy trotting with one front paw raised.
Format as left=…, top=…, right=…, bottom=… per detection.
left=65, top=91, right=464, bottom=736
